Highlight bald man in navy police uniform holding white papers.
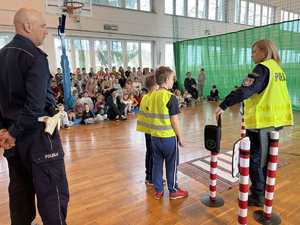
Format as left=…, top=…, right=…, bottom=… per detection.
left=0, top=8, right=69, bottom=225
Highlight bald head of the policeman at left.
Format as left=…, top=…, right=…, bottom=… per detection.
left=14, top=8, right=48, bottom=46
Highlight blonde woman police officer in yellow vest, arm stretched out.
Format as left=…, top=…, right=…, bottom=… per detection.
left=215, top=40, right=293, bottom=207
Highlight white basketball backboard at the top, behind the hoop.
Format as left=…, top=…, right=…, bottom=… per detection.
left=45, top=0, right=92, bottom=17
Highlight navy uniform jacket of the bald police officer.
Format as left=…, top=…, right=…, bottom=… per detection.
left=0, top=34, right=55, bottom=138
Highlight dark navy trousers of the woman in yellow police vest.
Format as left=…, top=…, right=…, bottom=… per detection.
left=246, top=128, right=275, bottom=197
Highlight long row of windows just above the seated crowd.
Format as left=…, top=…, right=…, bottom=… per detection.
left=54, top=37, right=153, bottom=69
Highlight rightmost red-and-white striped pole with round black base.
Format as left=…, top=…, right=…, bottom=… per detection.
left=253, top=131, right=281, bottom=225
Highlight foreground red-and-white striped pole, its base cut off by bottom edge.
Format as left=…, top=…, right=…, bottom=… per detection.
left=238, top=137, right=250, bottom=225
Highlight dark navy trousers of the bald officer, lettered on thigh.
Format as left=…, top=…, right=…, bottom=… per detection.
left=4, top=127, right=69, bottom=225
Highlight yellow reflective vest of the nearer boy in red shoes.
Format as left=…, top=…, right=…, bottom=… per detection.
left=148, top=89, right=176, bottom=138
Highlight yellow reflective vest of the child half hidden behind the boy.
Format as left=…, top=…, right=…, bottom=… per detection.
left=136, top=92, right=153, bottom=134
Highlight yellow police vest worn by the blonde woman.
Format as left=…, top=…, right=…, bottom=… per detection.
left=244, top=59, right=293, bottom=129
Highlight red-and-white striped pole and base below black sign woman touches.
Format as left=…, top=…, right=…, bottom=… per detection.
left=201, top=152, right=224, bottom=208
